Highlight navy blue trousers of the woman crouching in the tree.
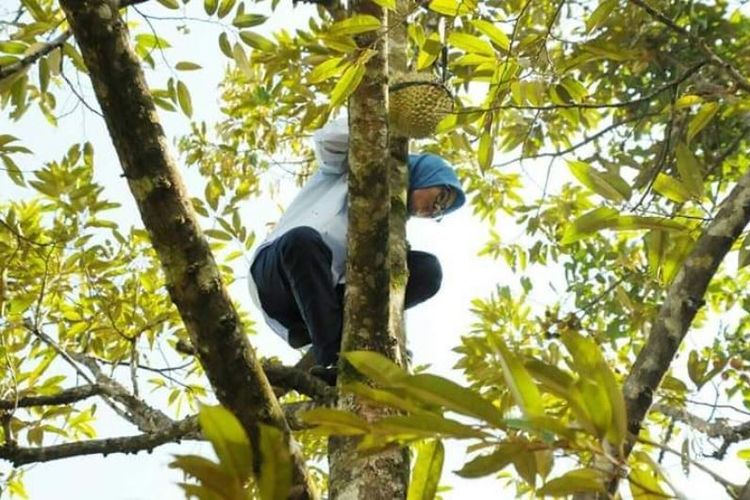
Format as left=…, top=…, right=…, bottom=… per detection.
left=250, top=226, right=443, bottom=366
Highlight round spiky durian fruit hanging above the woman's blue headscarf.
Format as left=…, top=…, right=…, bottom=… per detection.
left=388, top=73, right=453, bottom=139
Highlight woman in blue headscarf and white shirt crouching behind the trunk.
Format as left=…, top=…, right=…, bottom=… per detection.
left=249, top=118, right=466, bottom=383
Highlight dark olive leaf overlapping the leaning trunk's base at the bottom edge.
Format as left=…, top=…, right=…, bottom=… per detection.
left=258, top=424, right=292, bottom=500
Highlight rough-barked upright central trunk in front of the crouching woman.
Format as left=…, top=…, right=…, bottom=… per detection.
left=328, top=0, right=408, bottom=500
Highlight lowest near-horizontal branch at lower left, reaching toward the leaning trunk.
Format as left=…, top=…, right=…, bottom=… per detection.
left=0, top=416, right=201, bottom=467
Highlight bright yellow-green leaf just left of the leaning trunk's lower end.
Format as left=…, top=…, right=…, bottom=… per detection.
left=198, top=405, right=252, bottom=479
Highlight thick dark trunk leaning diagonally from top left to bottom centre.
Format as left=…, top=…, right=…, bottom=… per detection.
left=61, top=0, right=316, bottom=498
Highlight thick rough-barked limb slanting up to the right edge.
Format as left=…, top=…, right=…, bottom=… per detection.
left=610, top=171, right=750, bottom=491
